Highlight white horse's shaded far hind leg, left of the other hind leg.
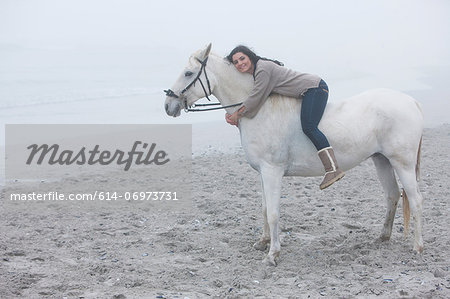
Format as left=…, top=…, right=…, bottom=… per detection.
left=372, top=154, right=400, bottom=241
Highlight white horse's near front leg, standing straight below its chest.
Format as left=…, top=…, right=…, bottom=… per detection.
left=261, top=165, right=284, bottom=266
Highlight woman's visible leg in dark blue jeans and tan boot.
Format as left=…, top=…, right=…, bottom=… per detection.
left=300, top=80, right=345, bottom=189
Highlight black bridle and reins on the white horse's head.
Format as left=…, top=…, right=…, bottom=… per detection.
left=164, top=57, right=242, bottom=112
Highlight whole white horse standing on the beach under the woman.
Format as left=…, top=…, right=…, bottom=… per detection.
left=165, top=44, right=423, bottom=265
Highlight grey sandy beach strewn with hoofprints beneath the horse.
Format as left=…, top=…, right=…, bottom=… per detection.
left=0, top=125, right=450, bottom=298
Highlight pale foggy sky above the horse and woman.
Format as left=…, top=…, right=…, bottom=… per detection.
left=0, top=0, right=450, bottom=95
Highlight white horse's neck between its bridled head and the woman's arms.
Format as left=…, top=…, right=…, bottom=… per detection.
left=208, top=55, right=253, bottom=111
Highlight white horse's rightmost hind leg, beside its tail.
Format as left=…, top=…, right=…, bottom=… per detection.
left=391, top=162, right=423, bottom=252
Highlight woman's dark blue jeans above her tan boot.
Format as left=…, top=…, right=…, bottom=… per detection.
left=300, top=80, right=330, bottom=150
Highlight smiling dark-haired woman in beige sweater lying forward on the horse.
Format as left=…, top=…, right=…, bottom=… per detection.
left=225, top=45, right=344, bottom=189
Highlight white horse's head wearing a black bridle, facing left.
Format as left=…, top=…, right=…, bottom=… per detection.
left=164, top=44, right=213, bottom=117
